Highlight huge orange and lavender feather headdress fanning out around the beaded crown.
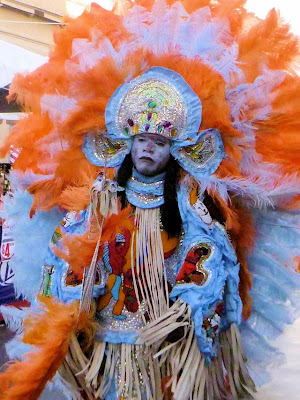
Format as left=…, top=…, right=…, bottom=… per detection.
left=2, top=0, right=300, bottom=396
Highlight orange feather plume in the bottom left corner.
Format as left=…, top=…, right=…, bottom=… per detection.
left=0, top=296, right=82, bottom=400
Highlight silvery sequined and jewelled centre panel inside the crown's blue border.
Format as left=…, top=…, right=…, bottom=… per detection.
left=116, top=78, right=187, bottom=138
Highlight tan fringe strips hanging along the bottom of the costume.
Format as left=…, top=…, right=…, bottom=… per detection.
left=60, top=320, right=255, bottom=400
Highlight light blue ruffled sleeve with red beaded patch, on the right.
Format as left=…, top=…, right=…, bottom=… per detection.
left=170, top=184, right=242, bottom=361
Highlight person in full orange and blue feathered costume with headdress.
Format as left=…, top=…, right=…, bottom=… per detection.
left=0, top=0, right=300, bottom=400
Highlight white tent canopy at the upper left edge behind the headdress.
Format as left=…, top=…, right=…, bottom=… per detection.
left=0, top=40, right=48, bottom=88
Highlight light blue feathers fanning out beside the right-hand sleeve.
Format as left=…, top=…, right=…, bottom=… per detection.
left=241, top=209, right=300, bottom=384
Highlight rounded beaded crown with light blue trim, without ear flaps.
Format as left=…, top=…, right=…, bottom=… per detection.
left=105, top=67, right=202, bottom=143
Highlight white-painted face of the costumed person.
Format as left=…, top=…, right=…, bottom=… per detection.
left=131, top=133, right=170, bottom=176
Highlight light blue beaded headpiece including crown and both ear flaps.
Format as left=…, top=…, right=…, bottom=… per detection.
left=83, top=67, right=225, bottom=178
